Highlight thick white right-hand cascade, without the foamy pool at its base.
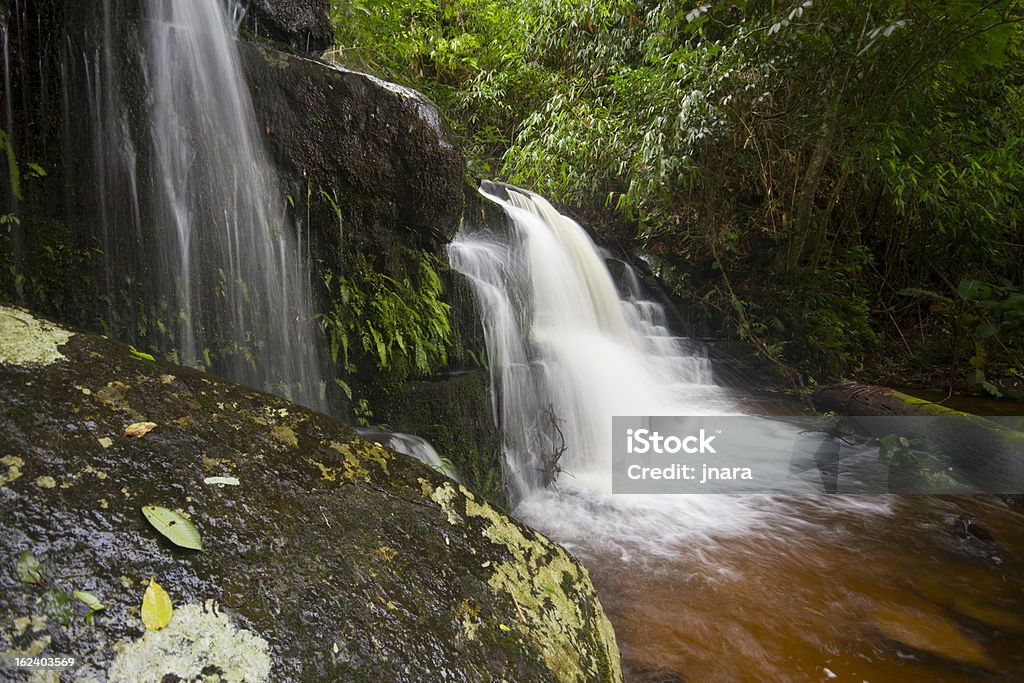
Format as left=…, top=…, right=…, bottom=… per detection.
left=449, top=183, right=731, bottom=498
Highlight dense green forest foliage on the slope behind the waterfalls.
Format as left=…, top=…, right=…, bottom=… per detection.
left=332, top=0, right=1024, bottom=392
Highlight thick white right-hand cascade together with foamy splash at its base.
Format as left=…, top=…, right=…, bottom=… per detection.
left=450, top=183, right=889, bottom=593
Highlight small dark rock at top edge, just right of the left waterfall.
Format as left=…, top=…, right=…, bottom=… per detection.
left=245, top=0, right=334, bottom=56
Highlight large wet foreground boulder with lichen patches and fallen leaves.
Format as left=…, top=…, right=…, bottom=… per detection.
left=0, top=306, right=622, bottom=682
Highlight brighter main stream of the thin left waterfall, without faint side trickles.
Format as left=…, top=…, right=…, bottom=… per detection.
left=146, top=0, right=319, bottom=405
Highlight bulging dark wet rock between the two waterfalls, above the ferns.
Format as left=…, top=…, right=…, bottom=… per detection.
left=239, top=43, right=463, bottom=256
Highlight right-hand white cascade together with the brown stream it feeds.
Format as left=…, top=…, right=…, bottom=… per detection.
left=450, top=183, right=1024, bottom=683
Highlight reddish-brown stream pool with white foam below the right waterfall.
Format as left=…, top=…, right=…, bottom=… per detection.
left=518, top=401, right=1024, bottom=683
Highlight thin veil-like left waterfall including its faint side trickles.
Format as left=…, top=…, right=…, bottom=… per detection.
left=65, top=0, right=323, bottom=408
